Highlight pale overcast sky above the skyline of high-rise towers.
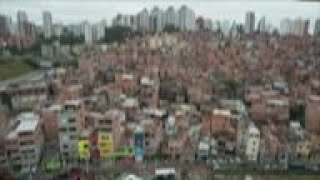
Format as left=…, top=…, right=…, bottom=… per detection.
left=0, top=0, right=320, bottom=27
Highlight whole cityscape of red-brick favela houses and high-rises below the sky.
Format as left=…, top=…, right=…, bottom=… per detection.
left=0, top=3, right=320, bottom=179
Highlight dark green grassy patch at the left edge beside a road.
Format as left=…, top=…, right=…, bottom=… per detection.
left=0, top=59, right=33, bottom=81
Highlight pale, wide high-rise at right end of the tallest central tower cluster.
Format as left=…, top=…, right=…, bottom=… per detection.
left=178, top=5, right=196, bottom=31
